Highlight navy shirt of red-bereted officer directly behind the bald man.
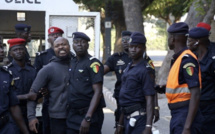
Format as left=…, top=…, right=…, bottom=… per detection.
left=34, top=48, right=55, bottom=72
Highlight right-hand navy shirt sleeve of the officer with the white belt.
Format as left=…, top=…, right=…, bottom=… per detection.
left=142, top=69, right=155, bottom=96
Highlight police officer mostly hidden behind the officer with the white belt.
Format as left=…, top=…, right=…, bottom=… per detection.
left=104, top=31, right=159, bottom=125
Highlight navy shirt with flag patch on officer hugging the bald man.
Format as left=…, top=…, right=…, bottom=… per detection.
left=68, top=55, right=105, bottom=109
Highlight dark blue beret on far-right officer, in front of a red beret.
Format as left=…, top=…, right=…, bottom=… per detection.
left=188, top=27, right=209, bottom=39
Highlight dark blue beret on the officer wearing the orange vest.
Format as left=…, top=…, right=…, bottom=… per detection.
left=167, top=22, right=189, bottom=34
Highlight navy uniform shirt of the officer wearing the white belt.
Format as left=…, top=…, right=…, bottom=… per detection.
left=119, top=60, right=155, bottom=107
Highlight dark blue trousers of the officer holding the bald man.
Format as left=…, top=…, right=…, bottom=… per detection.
left=67, top=109, right=104, bottom=134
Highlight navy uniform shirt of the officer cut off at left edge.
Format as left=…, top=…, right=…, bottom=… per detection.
left=0, top=68, right=19, bottom=115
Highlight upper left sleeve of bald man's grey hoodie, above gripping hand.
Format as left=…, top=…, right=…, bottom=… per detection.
left=31, top=66, right=52, bottom=93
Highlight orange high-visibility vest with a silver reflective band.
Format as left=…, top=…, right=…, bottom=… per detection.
left=166, top=50, right=202, bottom=104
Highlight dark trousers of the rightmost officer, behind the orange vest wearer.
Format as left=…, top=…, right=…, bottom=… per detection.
left=200, top=103, right=215, bottom=134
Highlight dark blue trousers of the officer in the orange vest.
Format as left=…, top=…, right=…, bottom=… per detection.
left=170, top=106, right=203, bottom=134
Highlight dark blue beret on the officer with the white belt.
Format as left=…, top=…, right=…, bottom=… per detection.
left=129, top=32, right=146, bottom=45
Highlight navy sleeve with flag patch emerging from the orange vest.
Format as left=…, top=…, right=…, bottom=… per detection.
left=181, top=55, right=200, bottom=88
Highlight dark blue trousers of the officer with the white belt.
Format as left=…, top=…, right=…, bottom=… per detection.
left=124, top=115, right=146, bottom=134
